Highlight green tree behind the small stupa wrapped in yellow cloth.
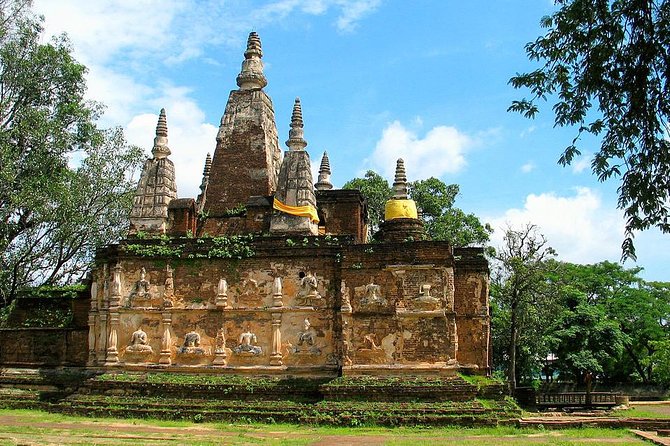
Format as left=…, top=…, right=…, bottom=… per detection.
left=343, top=170, right=493, bottom=246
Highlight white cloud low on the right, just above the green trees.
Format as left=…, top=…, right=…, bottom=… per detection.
left=483, top=187, right=623, bottom=263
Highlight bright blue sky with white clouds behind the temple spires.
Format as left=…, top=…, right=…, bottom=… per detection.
left=35, top=0, right=670, bottom=280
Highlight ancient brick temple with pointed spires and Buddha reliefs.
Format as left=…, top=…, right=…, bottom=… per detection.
left=88, top=33, right=490, bottom=376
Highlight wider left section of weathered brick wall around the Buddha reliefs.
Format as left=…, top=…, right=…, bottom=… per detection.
left=95, top=239, right=337, bottom=366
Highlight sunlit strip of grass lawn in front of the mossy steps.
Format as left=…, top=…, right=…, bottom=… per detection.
left=0, top=410, right=648, bottom=446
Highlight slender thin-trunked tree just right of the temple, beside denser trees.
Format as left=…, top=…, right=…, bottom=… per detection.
left=491, top=224, right=556, bottom=389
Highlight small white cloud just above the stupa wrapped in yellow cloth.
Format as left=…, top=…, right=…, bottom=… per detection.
left=368, top=121, right=474, bottom=180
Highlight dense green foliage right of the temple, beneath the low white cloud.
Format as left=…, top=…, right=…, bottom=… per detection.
left=491, top=235, right=670, bottom=383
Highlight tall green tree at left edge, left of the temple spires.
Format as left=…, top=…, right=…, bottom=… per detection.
left=0, top=5, right=141, bottom=305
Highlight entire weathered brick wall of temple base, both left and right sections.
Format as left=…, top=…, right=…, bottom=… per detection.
left=88, top=236, right=489, bottom=371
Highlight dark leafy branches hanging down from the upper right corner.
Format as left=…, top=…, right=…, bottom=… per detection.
left=509, top=0, right=670, bottom=259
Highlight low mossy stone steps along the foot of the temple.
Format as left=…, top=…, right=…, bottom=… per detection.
left=0, top=370, right=521, bottom=426
